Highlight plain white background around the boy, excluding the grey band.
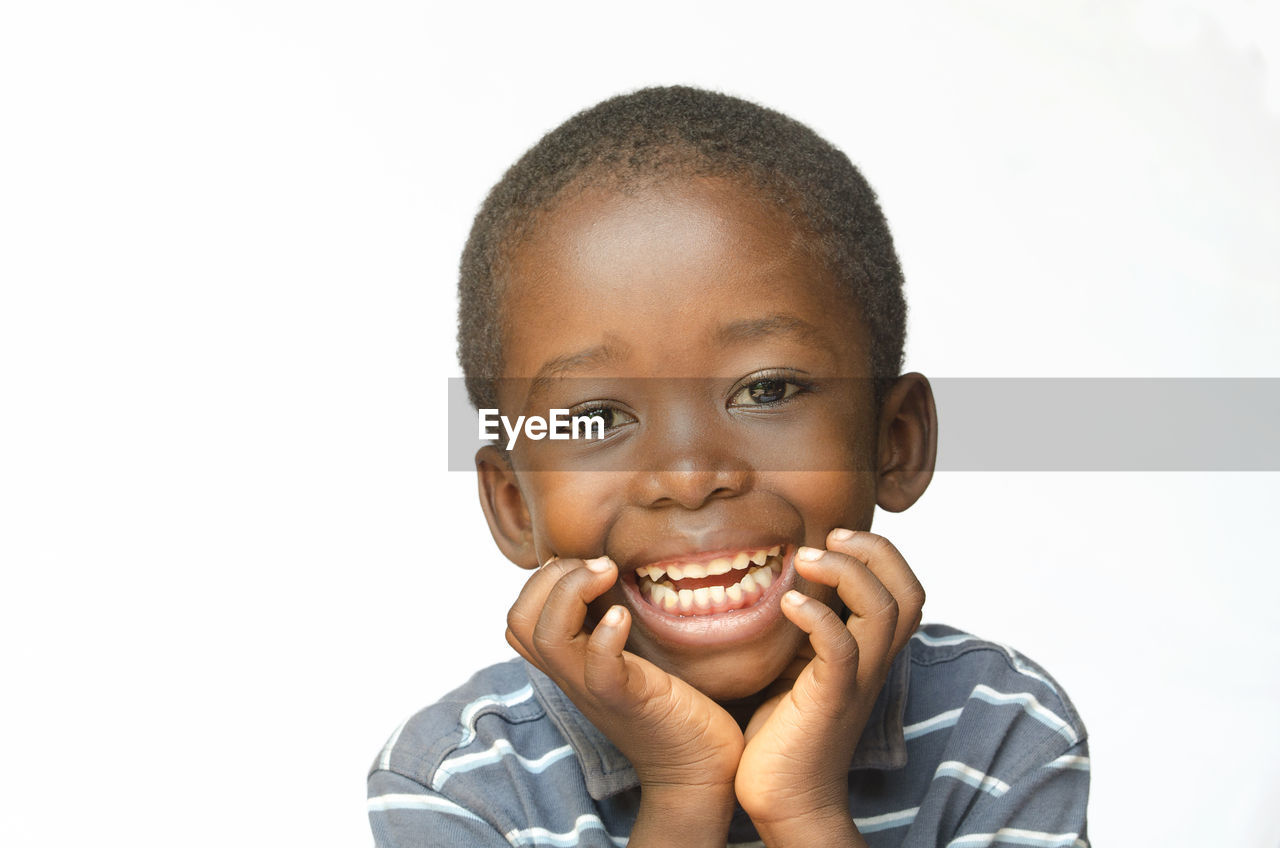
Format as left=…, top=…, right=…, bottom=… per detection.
left=0, top=0, right=1280, bottom=845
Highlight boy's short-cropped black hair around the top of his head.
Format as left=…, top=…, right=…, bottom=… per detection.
left=458, top=86, right=906, bottom=409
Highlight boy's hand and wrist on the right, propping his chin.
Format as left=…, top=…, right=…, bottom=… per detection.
left=736, top=529, right=924, bottom=845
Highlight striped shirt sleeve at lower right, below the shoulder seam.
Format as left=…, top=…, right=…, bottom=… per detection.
left=946, top=739, right=1089, bottom=848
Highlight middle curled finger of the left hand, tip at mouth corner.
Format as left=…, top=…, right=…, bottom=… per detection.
left=532, top=557, right=617, bottom=681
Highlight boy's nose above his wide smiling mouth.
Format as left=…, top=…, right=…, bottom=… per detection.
left=637, top=416, right=754, bottom=510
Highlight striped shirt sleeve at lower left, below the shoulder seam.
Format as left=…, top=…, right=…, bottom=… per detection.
left=369, top=770, right=509, bottom=848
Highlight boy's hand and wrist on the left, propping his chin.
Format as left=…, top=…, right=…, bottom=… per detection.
left=507, top=557, right=742, bottom=845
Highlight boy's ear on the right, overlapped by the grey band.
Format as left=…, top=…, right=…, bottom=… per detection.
left=876, top=373, right=938, bottom=512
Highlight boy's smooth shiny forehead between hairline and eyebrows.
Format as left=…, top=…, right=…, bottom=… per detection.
left=503, top=177, right=865, bottom=377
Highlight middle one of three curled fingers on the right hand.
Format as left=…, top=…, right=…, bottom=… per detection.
left=795, top=547, right=899, bottom=669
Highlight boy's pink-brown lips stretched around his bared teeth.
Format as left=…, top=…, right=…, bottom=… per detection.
left=620, top=539, right=796, bottom=647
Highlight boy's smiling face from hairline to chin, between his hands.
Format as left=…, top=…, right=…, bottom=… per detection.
left=481, top=178, right=878, bottom=701
